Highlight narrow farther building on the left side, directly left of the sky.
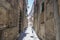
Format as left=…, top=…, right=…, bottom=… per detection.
left=23, top=0, right=28, bottom=30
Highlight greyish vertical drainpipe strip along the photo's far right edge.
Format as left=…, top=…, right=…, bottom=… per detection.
left=53, top=0, right=60, bottom=40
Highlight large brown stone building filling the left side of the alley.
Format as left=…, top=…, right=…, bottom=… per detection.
left=0, top=0, right=26, bottom=40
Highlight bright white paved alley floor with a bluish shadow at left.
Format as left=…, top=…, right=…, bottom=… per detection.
left=18, top=26, right=39, bottom=40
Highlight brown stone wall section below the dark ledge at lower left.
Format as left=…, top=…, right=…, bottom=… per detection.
left=1, top=27, right=19, bottom=40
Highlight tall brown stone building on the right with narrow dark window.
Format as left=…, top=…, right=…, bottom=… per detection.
left=34, top=0, right=60, bottom=40
